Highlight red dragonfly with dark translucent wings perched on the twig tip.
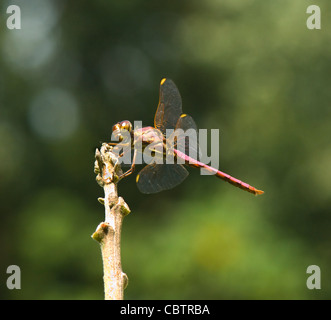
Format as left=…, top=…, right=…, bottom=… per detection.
left=109, top=78, right=264, bottom=195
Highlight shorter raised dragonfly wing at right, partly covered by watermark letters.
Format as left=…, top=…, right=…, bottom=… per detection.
left=169, top=114, right=201, bottom=160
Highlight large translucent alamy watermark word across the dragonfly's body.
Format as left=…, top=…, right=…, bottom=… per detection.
left=111, top=121, right=219, bottom=175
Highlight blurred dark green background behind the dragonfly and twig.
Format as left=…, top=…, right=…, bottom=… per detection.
left=0, top=0, right=331, bottom=299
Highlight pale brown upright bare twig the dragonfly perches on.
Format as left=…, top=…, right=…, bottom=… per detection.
left=92, top=143, right=130, bottom=300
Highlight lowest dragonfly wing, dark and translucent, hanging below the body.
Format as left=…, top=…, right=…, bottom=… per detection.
left=137, top=163, right=188, bottom=194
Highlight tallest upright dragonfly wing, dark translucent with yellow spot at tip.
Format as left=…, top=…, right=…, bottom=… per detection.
left=154, top=78, right=182, bottom=134
